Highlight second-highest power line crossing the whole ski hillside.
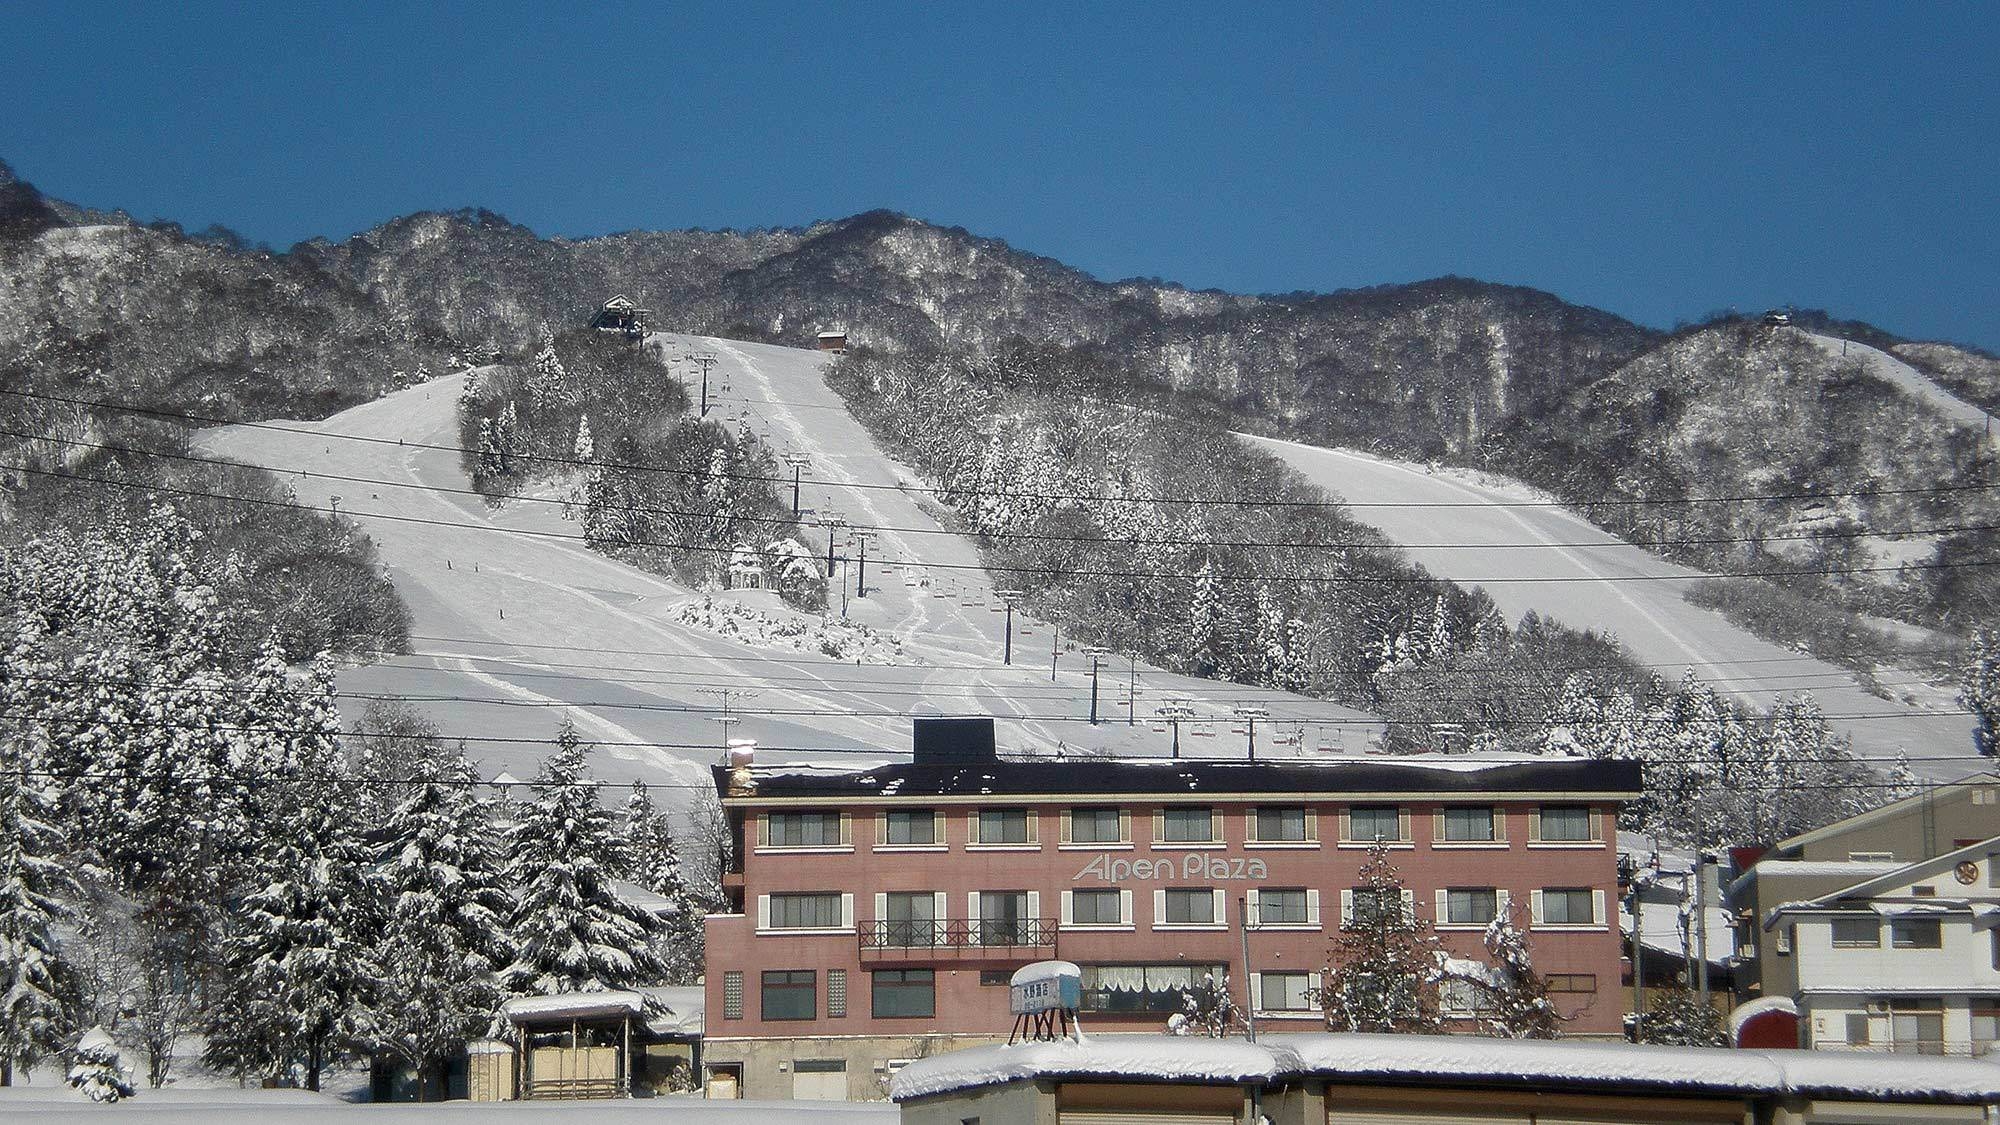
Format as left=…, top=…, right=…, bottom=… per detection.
left=15, top=422, right=2000, bottom=550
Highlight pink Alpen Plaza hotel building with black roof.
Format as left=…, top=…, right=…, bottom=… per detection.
left=704, top=719, right=1640, bottom=1099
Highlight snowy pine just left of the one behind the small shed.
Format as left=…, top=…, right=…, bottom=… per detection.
left=374, top=755, right=512, bottom=1101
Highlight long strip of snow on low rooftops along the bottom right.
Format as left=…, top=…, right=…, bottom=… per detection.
left=890, top=1035, right=2000, bottom=1103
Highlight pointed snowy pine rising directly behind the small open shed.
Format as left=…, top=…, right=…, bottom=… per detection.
left=502, top=721, right=666, bottom=995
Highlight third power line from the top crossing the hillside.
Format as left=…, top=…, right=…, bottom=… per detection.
left=0, top=462, right=2000, bottom=587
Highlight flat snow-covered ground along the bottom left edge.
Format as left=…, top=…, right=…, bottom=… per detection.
left=0, top=1085, right=900, bottom=1125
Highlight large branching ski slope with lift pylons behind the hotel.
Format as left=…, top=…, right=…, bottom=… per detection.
left=198, top=336, right=1374, bottom=801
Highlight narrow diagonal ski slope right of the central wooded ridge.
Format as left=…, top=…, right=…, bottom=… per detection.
left=1246, top=436, right=1978, bottom=779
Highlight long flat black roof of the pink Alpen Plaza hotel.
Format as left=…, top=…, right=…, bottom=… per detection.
left=714, top=755, right=1640, bottom=799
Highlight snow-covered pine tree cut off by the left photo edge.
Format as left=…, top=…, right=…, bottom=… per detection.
left=0, top=723, right=80, bottom=1085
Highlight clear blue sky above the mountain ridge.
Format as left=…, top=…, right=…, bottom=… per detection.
left=0, top=2, right=2000, bottom=348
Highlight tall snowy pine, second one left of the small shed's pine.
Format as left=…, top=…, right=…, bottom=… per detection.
left=204, top=657, right=382, bottom=1089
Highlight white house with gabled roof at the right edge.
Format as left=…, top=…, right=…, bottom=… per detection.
left=1764, top=837, right=2000, bottom=1055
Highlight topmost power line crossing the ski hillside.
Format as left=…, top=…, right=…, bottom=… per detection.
left=15, top=388, right=2000, bottom=508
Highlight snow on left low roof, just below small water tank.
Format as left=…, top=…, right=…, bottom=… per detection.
left=890, top=1035, right=1280, bottom=1101
